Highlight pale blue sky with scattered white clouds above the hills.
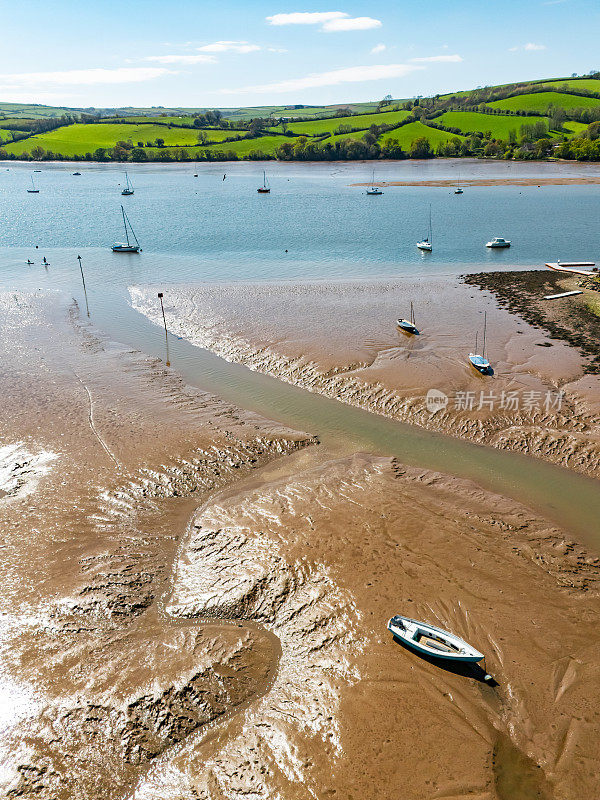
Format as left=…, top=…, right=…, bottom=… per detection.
left=0, top=0, right=600, bottom=108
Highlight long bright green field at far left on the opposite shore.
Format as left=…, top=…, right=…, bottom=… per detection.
left=6, top=123, right=241, bottom=156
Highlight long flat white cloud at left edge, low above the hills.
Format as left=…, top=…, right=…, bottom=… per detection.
left=0, top=67, right=177, bottom=91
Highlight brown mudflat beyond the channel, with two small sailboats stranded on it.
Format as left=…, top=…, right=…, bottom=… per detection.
left=130, top=277, right=600, bottom=476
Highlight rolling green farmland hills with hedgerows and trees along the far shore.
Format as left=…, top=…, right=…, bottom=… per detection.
left=0, top=73, right=600, bottom=162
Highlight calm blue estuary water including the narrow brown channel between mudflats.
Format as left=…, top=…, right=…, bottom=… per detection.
left=0, top=161, right=600, bottom=545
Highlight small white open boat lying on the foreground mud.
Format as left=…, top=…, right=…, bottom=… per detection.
left=387, top=614, right=484, bottom=664
